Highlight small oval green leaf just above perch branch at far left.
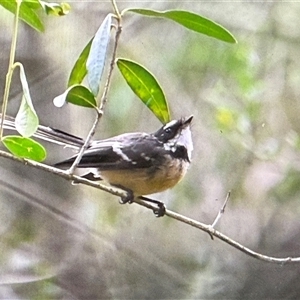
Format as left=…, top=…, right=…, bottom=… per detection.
left=2, top=135, right=47, bottom=162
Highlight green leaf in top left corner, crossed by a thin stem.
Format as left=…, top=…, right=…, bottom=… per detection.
left=0, top=0, right=44, bottom=32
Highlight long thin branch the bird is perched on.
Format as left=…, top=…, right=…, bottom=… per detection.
left=0, top=150, right=300, bottom=265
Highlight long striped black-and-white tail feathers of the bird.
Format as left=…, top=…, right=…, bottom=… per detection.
left=0, top=114, right=84, bottom=150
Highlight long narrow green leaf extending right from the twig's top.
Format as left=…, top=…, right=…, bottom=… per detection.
left=128, top=8, right=237, bottom=43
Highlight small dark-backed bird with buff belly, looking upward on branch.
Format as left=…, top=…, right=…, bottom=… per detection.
left=1, top=116, right=193, bottom=216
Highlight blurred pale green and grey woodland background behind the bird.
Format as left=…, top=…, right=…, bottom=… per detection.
left=0, top=0, right=300, bottom=299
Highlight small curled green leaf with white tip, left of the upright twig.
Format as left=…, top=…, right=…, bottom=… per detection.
left=53, top=84, right=97, bottom=108
